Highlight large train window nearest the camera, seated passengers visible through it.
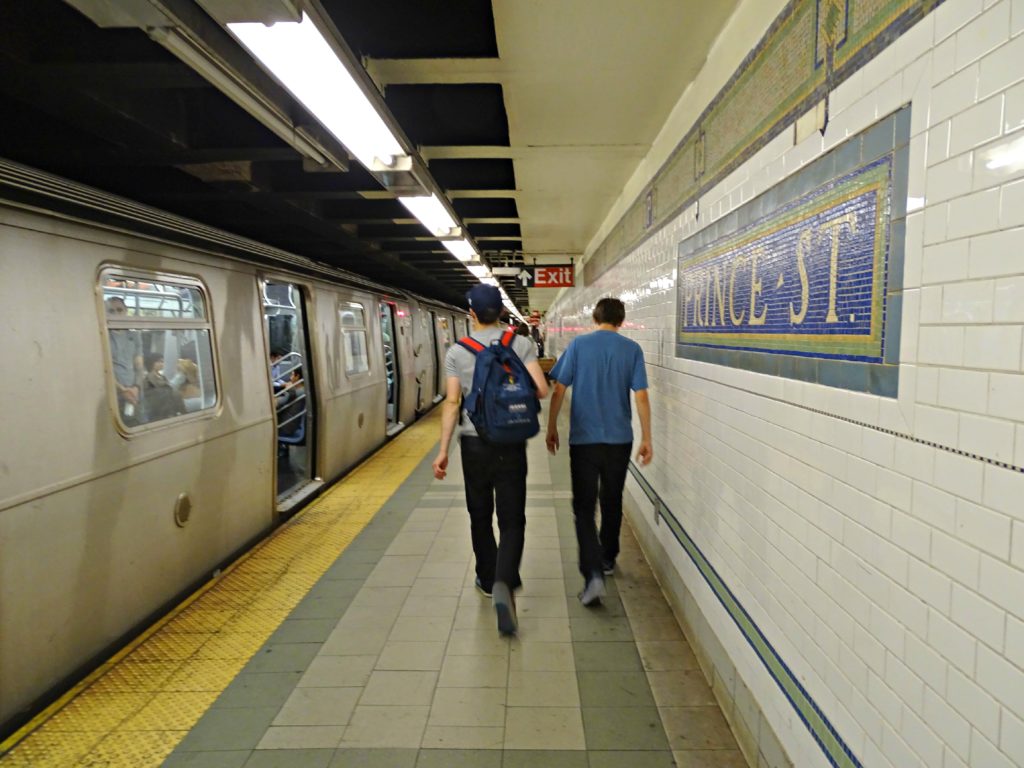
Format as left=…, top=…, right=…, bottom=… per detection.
left=99, top=268, right=217, bottom=431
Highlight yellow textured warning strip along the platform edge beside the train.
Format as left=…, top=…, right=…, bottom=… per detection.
left=0, top=411, right=439, bottom=768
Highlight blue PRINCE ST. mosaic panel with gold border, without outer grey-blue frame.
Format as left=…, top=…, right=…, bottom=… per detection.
left=677, top=158, right=891, bottom=362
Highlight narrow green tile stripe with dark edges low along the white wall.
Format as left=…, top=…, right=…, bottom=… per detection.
left=630, top=462, right=862, bottom=768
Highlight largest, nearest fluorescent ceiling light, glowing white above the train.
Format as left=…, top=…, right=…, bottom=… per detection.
left=227, top=13, right=406, bottom=170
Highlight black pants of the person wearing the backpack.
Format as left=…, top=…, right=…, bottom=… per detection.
left=460, top=437, right=526, bottom=592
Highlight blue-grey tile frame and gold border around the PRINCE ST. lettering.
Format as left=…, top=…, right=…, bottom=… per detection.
left=676, top=105, right=910, bottom=397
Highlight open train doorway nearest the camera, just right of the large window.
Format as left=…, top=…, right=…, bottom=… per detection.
left=263, top=281, right=316, bottom=501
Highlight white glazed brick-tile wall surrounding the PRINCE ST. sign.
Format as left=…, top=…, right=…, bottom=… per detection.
left=549, top=0, right=1024, bottom=768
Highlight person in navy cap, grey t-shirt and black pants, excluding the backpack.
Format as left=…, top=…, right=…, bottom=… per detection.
left=433, top=283, right=548, bottom=635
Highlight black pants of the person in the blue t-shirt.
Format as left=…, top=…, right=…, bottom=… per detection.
left=569, top=442, right=633, bottom=579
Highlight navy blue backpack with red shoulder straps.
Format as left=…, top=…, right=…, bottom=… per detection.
left=459, top=331, right=541, bottom=444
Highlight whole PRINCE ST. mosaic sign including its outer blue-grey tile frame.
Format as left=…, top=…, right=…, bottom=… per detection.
left=676, top=108, right=909, bottom=396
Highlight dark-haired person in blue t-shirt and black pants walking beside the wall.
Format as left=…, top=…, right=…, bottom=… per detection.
left=547, top=298, right=654, bottom=605
